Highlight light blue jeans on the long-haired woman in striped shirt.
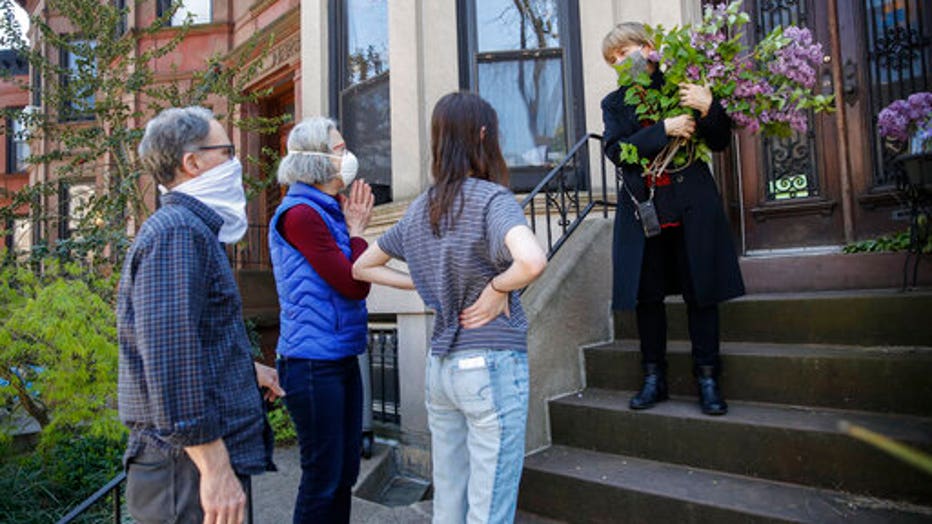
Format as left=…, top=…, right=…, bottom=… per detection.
left=426, top=349, right=528, bottom=524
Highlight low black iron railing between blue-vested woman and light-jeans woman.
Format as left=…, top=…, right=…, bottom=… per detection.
left=368, top=324, right=401, bottom=424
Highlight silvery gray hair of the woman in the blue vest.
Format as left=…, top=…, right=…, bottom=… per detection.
left=278, top=116, right=337, bottom=186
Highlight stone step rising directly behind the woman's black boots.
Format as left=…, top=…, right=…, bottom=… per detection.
left=584, top=340, right=932, bottom=416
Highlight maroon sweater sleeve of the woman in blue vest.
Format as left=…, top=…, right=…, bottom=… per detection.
left=278, top=204, right=371, bottom=300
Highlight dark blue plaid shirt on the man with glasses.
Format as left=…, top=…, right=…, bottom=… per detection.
left=117, top=192, right=274, bottom=475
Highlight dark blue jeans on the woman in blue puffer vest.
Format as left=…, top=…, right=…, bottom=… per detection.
left=278, top=357, right=362, bottom=524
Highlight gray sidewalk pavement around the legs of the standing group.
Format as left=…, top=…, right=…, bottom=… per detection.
left=252, top=445, right=557, bottom=524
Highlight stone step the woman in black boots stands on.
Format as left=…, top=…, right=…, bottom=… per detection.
left=550, top=389, right=932, bottom=504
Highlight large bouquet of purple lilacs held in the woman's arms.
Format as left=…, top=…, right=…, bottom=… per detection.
left=616, top=0, right=832, bottom=169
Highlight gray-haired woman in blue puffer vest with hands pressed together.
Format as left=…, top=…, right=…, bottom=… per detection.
left=269, top=117, right=373, bottom=524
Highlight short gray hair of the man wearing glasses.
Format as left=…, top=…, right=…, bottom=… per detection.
left=139, top=106, right=214, bottom=185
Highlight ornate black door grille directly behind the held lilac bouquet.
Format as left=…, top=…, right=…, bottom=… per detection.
left=755, top=0, right=819, bottom=200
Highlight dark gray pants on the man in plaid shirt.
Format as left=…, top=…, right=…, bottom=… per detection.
left=126, top=446, right=253, bottom=524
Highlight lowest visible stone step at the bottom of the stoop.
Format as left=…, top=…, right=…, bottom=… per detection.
left=518, top=446, right=932, bottom=524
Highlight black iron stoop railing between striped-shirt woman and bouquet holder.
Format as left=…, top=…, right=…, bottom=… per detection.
left=521, top=133, right=617, bottom=259
